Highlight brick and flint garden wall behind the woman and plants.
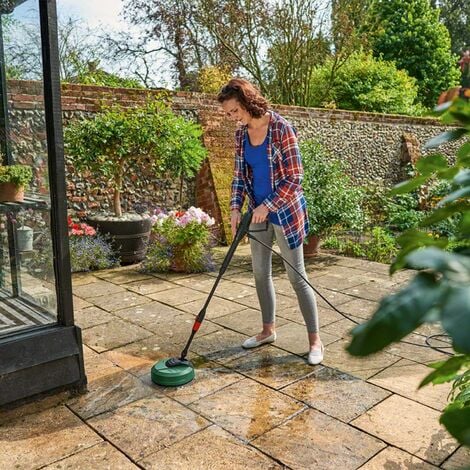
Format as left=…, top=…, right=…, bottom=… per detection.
left=8, top=81, right=454, bottom=242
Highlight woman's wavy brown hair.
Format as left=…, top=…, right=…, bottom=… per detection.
left=217, top=78, right=268, bottom=118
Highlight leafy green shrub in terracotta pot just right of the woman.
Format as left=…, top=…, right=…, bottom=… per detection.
left=300, top=140, right=364, bottom=256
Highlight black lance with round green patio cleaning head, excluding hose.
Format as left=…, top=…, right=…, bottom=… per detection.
left=150, top=212, right=255, bottom=387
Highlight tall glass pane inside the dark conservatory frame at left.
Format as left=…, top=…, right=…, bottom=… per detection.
left=0, top=0, right=57, bottom=338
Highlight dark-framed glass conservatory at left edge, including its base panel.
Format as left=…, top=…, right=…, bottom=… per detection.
left=0, top=0, right=86, bottom=405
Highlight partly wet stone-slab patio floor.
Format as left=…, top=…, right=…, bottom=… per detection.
left=0, top=245, right=470, bottom=470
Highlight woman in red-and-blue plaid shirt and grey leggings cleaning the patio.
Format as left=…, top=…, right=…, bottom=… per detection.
left=217, top=78, right=323, bottom=365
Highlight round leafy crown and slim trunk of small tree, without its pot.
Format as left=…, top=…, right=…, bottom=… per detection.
left=64, top=99, right=206, bottom=216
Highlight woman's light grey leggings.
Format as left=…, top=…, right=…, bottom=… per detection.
left=246, top=222, right=319, bottom=333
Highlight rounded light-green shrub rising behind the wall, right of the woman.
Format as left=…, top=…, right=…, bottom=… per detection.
left=310, top=53, right=423, bottom=115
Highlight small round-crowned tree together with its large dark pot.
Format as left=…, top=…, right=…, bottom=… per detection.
left=64, top=99, right=206, bottom=263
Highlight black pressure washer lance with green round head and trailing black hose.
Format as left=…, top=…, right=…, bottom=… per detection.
left=151, top=212, right=452, bottom=386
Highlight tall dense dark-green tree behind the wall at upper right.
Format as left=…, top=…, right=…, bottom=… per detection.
left=364, top=0, right=459, bottom=107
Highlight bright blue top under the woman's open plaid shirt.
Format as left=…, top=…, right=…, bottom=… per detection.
left=245, top=132, right=281, bottom=225
